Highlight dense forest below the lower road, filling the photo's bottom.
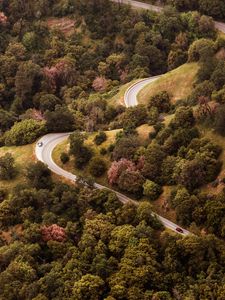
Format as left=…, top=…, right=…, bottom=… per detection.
left=0, top=163, right=225, bottom=300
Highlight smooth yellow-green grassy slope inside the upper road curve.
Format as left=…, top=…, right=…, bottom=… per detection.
left=138, top=63, right=198, bottom=104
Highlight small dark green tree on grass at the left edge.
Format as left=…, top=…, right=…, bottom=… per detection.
left=0, top=153, right=16, bottom=180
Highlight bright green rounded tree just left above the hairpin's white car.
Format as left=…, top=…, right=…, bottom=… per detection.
left=4, top=119, right=46, bottom=146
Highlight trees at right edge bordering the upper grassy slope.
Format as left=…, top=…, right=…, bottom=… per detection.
left=188, top=39, right=225, bottom=135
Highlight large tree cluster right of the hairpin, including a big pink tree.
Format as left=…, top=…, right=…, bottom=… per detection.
left=108, top=105, right=221, bottom=199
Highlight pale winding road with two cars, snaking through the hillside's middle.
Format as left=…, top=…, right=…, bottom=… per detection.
left=35, top=76, right=190, bottom=235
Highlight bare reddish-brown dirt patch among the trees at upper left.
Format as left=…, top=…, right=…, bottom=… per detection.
left=47, top=18, right=75, bottom=35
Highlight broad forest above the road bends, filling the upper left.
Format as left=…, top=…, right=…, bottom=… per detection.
left=0, top=0, right=216, bottom=145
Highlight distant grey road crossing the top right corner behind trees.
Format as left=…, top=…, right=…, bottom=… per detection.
left=111, top=0, right=225, bottom=33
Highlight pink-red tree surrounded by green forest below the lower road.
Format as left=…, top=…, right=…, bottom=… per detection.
left=41, top=224, right=66, bottom=242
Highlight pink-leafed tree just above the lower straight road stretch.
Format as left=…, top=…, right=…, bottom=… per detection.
left=107, top=158, right=136, bottom=185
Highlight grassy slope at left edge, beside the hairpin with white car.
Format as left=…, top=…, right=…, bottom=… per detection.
left=0, top=144, right=35, bottom=189
